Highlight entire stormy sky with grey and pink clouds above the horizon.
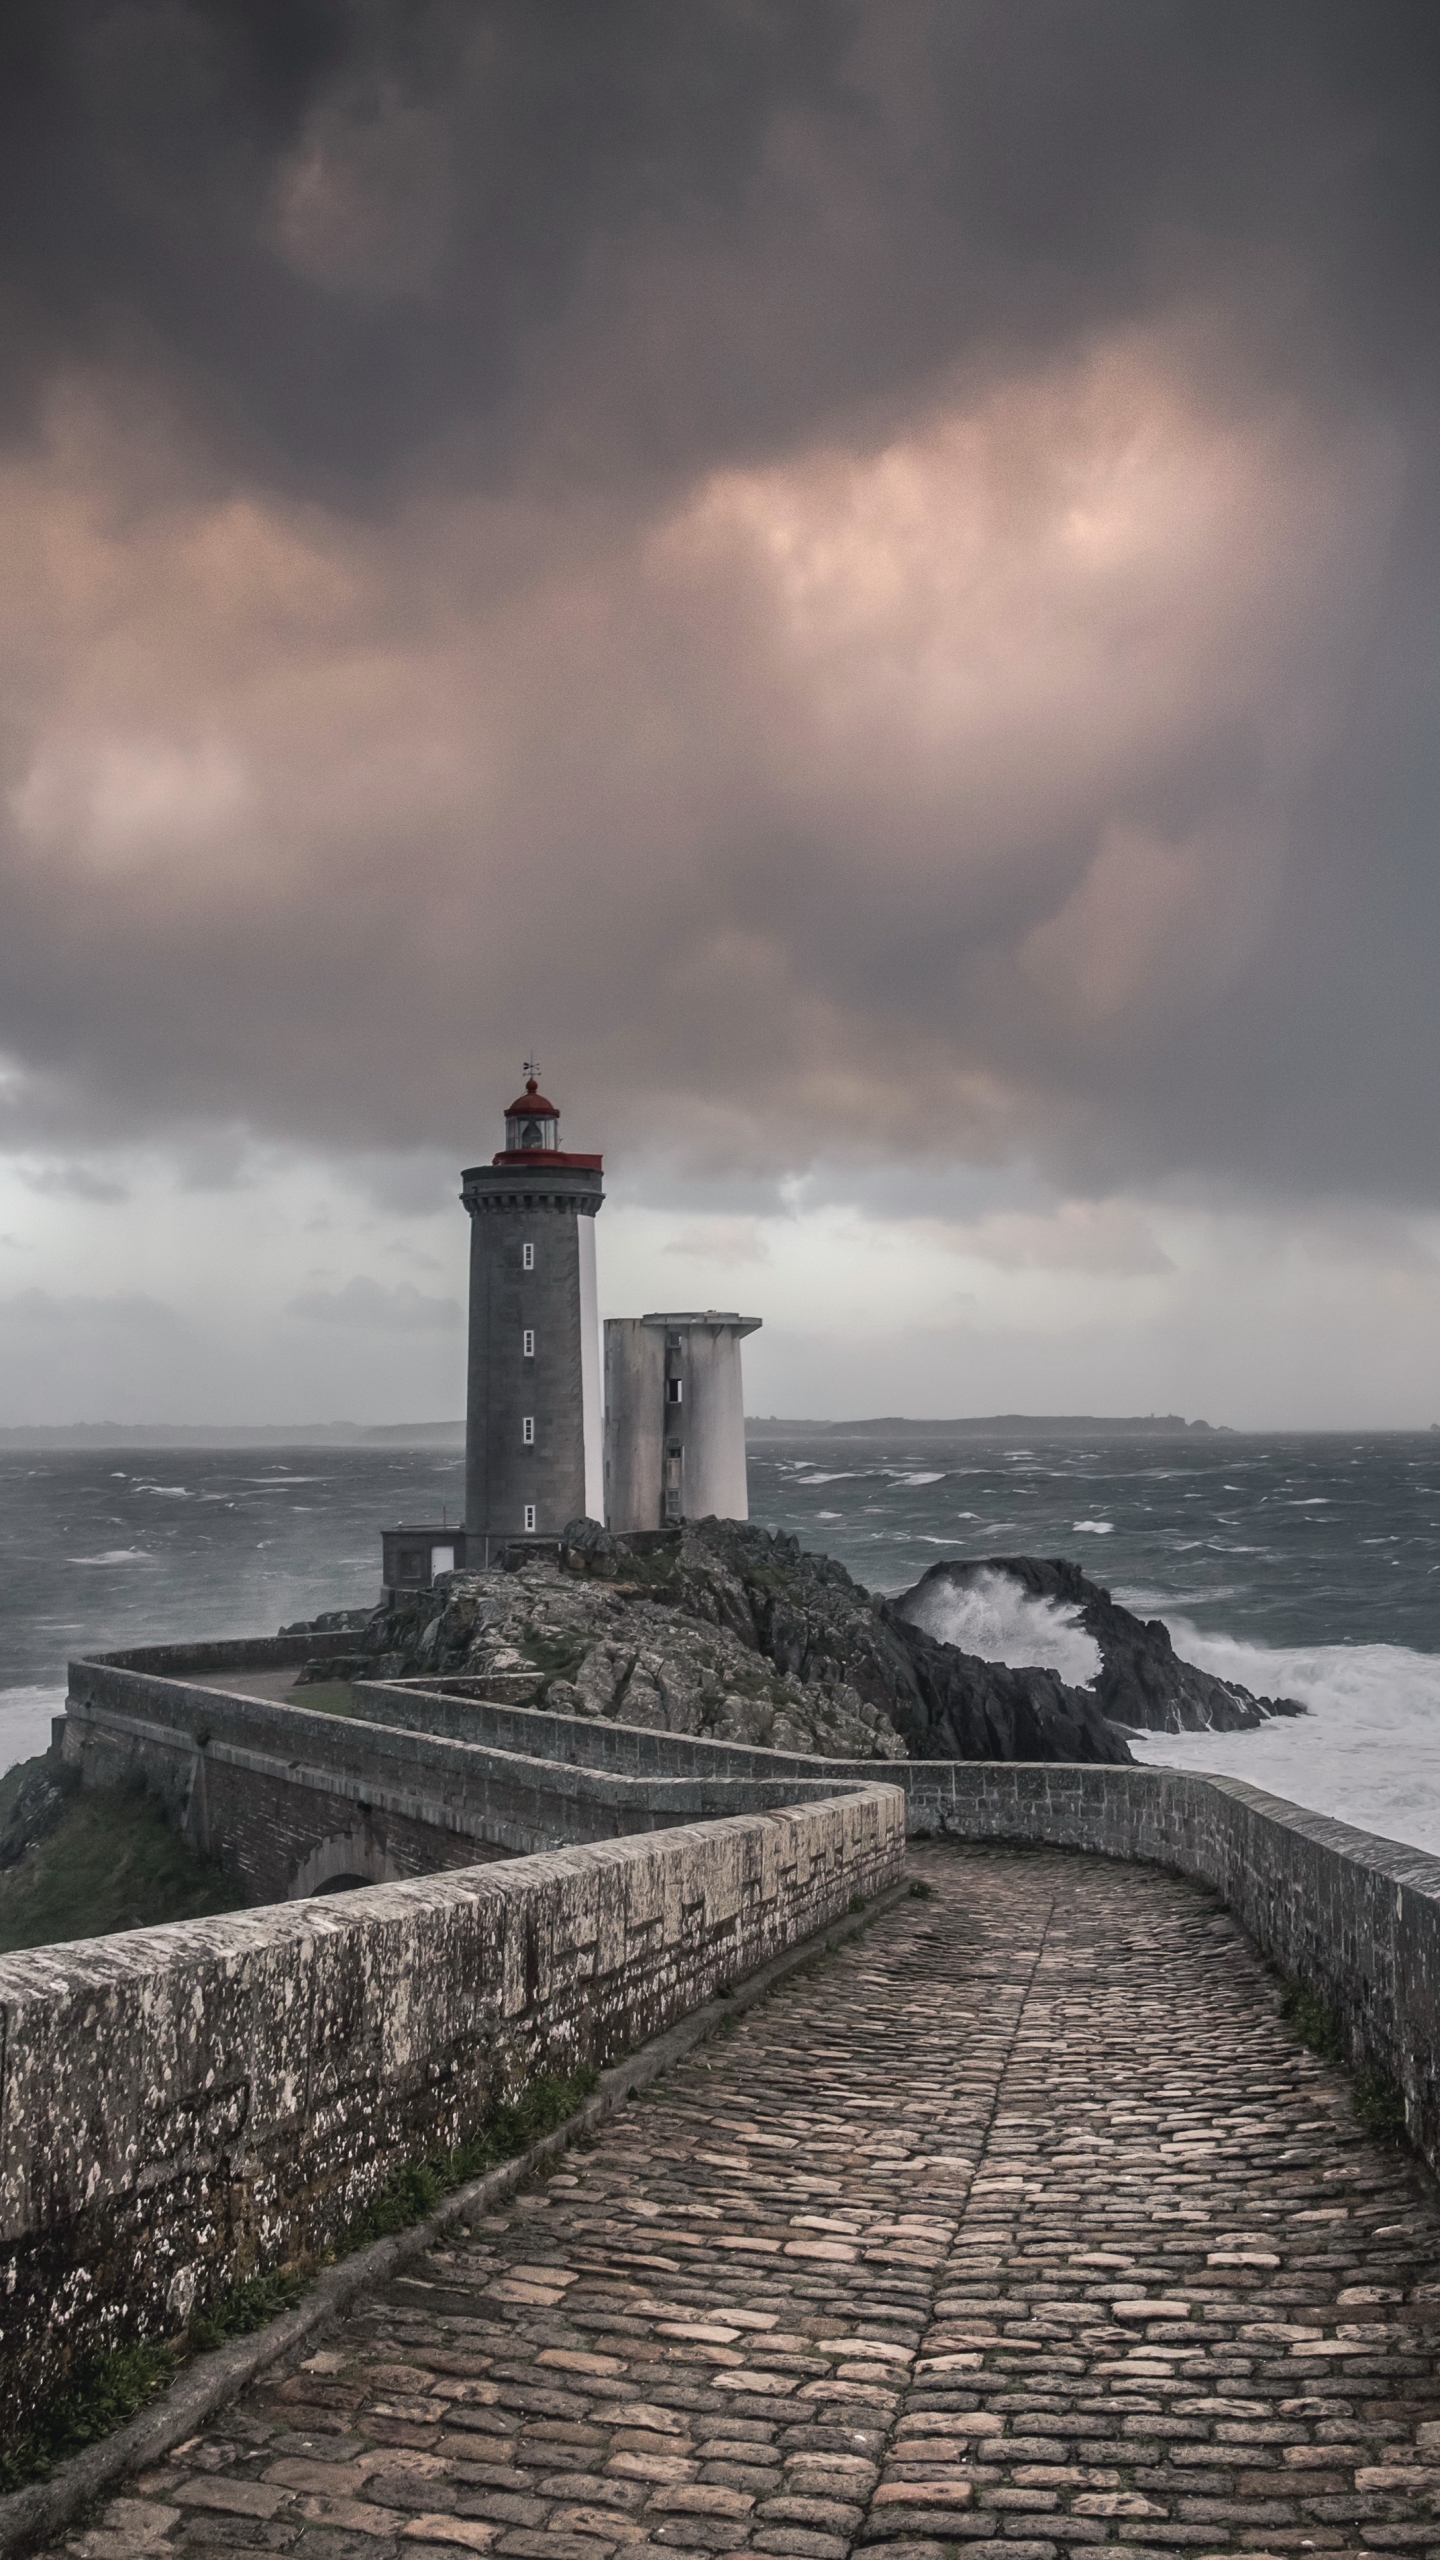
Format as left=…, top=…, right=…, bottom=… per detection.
left=0, top=0, right=1440, bottom=1423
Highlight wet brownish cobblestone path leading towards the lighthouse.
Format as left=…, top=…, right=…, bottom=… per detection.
left=69, top=1848, right=1440, bottom=2560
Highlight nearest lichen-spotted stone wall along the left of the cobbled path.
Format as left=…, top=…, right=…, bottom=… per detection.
left=0, top=1784, right=904, bottom=2432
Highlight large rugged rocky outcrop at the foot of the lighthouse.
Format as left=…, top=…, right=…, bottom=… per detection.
left=313, top=1521, right=1130, bottom=1761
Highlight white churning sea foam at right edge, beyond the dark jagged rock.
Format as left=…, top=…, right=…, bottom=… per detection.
left=1130, top=1618, right=1440, bottom=1853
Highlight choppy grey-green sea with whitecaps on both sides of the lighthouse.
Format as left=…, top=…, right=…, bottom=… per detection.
left=0, top=1423, right=1440, bottom=1851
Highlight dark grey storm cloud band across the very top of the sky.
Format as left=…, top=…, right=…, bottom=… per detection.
left=11, top=0, right=1440, bottom=489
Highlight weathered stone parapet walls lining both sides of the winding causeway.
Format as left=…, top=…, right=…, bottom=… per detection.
left=19, top=1638, right=1440, bottom=2437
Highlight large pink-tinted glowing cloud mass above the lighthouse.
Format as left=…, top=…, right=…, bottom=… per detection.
left=0, top=320, right=1396, bottom=1172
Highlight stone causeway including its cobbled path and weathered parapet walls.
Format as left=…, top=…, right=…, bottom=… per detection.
left=0, top=1656, right=1440, bottom=2560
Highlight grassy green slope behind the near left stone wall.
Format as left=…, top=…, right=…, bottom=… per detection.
left=0, top=1764, right=243, bottom=1956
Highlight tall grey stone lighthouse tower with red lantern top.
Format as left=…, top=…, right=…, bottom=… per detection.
left=461, top=1073, right=605, bottom=1564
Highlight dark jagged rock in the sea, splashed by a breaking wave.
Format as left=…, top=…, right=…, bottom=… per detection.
left=894, top=1556, right=1304, bottom=1733
